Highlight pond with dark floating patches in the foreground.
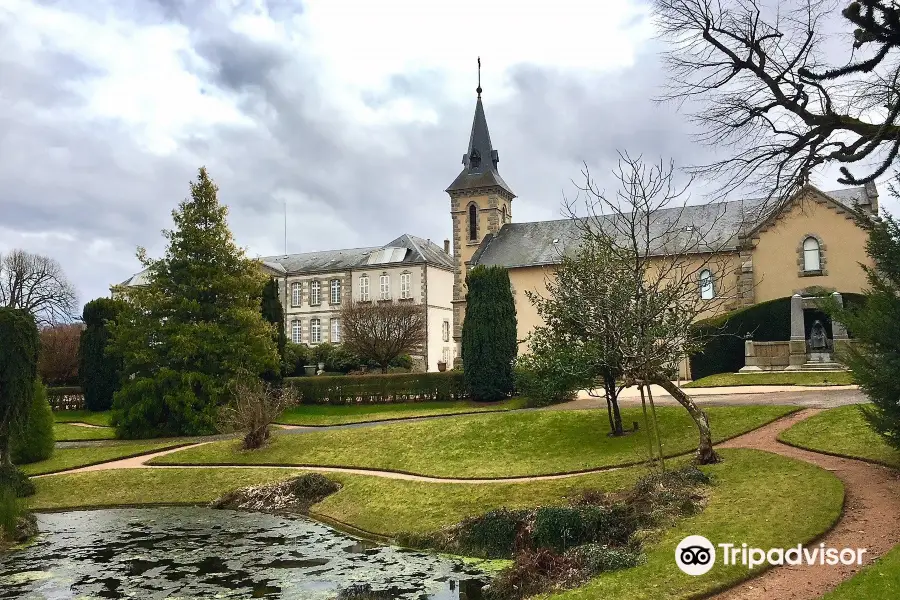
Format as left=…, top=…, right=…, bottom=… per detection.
left=0, top=507, right=483, bottom=600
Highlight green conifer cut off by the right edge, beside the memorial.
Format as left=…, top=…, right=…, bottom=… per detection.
left=839, top=206, right=900, bottom=450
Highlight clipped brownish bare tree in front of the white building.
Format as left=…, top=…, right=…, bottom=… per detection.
left=341, top=300, right=427, bottom=373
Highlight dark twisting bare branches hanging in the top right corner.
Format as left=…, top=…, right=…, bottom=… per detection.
left=654, top=0, right=900, bottom=200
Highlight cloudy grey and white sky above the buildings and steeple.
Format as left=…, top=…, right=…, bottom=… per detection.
left=0, top=0, right=886, bottom=310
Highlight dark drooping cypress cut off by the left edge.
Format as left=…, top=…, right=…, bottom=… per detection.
left=0, top=308, right=41, bottom=470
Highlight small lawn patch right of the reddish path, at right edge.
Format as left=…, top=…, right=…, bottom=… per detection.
left=778, top=405, right=900, bottom=468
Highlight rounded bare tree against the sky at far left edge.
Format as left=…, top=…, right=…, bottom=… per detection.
left=0, top=250, right=78, bottom=325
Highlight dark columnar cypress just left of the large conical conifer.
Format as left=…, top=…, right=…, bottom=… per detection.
left=78, top=298, right=122, bottom=410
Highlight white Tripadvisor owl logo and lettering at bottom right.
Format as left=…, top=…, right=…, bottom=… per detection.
left=675, top=535, right=867, bottom=576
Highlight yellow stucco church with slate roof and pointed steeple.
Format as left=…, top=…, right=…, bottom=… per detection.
left=446, top=85, right=878, bottom=368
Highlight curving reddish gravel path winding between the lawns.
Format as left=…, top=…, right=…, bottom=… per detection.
left=44, top=396, right=900, bottom=600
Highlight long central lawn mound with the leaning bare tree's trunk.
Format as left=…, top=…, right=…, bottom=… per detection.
left=154, top=406, right=795, bottom=477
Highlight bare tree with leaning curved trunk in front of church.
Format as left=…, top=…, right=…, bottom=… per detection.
left=560, top=154, right=739, bottom=464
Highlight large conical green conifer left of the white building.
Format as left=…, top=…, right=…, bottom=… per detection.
left=112, top=168, right=278, bottom=438
